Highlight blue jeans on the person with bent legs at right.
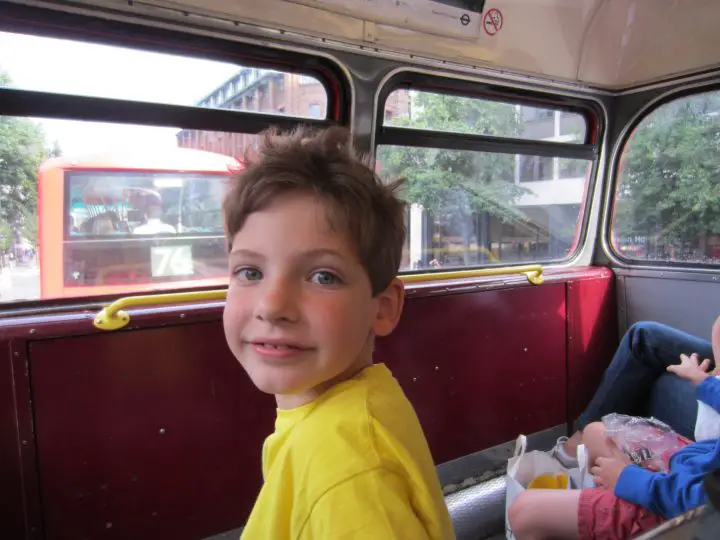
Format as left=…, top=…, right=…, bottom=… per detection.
left=575, top=322, right=714, bottom=439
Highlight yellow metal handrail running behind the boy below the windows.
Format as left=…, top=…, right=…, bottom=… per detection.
left=93, top=264, right=543, bottom=330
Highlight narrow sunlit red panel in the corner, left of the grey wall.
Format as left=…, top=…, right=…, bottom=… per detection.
left=567, top=269, right=618, bottom=422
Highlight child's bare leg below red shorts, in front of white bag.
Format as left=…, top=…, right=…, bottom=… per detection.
left=508, top=489, right=580, bottom=540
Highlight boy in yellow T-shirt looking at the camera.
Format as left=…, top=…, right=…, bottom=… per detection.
left=223, top=128, right=454, bottom=540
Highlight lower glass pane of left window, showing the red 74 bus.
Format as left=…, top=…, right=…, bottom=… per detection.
left=0, top=117, right=256, bottom=302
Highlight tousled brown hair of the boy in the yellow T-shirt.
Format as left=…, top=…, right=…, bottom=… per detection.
left=223, top=127, right=405, bottom=296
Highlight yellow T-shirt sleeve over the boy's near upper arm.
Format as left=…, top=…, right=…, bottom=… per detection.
left=298, top=469, right=430, bottom=540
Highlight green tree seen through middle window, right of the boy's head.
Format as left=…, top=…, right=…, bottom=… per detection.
left=378, top=92, right=526, bottom=263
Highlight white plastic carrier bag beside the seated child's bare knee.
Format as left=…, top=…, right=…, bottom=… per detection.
left=505, top=435, right=570, bottom=540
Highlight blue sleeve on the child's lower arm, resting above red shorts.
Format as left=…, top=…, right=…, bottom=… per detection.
left=615, top=465, right=705, bottom=519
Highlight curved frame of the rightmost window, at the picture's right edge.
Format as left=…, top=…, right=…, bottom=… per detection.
left=600, top=82, right=720, bottom=273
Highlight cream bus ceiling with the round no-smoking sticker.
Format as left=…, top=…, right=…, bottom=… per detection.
left=17, top=0, right=720, bottom=90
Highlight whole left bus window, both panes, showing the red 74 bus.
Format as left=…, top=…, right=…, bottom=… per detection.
left=0, top=32, right=327, bottom=302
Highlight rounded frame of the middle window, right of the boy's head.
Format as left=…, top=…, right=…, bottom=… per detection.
left=373, top=69, right=605, bottom=274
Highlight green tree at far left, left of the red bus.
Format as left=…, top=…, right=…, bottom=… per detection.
left=0, top=68, right=48, bottom=246
